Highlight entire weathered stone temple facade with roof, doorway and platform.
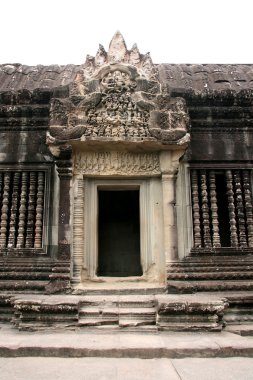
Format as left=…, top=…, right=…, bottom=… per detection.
left=0, top=32, right=253, bottom=330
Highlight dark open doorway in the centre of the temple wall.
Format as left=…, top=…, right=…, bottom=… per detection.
left=97, top=189, right=142, bottom=277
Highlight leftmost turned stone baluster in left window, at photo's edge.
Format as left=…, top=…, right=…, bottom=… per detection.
left=0, top=173, right=11, bottom=248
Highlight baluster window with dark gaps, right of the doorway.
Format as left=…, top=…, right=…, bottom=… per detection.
left=191, top=169, right=253, bottom=250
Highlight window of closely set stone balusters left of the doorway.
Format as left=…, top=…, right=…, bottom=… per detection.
left=0, top=170, right=46, bottom=250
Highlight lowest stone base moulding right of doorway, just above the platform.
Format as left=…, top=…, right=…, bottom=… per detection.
left=167, top=280, right=253, bottom=293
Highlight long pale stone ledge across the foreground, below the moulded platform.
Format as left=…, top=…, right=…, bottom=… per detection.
left=0, top=325, right=253, bottom=359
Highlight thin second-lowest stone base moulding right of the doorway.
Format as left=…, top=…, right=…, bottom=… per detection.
left=167, top=272, right=253, bottom=281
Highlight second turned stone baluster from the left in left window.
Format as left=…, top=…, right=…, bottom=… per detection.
left=8, top=172, right=20, bottom=248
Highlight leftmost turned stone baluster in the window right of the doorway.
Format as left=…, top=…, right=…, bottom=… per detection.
left=191, top=169, right=202, bottom=248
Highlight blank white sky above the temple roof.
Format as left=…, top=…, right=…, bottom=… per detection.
left=0, top=0, right=253, bottom=65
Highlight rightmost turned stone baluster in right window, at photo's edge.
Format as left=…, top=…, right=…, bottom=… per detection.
left=242, top=170, right=253, bottom=247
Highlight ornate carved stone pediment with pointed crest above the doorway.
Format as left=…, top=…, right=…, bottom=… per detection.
left=48, top=32, right=189, bottom=145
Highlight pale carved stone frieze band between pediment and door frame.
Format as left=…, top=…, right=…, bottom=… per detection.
left=74, top=152, right=161, bottom=176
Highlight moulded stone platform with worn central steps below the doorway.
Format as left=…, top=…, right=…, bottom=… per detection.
left=0, top=292, right=237, bottom=331
